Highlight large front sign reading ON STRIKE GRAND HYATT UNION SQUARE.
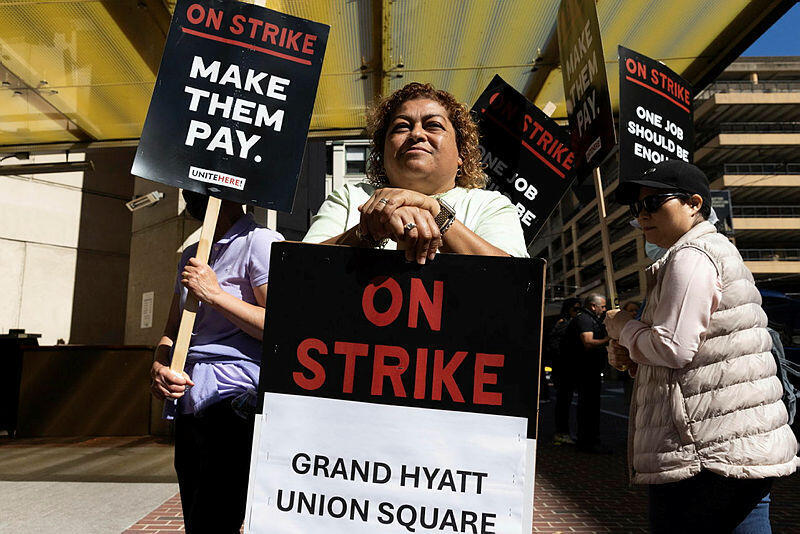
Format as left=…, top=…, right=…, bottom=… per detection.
left=245, top=243, right=544, bottom=534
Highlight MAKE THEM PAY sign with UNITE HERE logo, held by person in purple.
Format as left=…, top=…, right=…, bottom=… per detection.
left=131, top=0, right=329, bottom=211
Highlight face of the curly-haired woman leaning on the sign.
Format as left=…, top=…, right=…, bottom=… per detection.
left=383, top=98, right=462, bottom=195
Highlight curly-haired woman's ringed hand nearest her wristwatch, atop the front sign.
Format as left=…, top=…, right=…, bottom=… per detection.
left=382, top=206, right=442, bottom=264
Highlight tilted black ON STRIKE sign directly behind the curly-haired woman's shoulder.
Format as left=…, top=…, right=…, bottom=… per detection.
left=472, top=76, right=575, bottom=245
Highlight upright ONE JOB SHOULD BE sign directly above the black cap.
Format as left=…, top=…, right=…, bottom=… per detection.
left=619, top=46, right=694, bottom=180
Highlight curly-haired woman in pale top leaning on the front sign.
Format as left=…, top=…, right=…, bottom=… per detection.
left=303, top=82, right=527, bottom=264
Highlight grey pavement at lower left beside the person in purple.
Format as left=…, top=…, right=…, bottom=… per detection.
left=0, top=437, right=177, bottom=534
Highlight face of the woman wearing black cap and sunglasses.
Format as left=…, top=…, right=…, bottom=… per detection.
left=636, top=187, right=702, bottom=248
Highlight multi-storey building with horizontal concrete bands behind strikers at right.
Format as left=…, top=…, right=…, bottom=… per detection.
left=532, top=57, right=800, bottom=308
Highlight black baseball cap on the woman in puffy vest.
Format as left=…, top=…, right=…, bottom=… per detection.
left=617, top=159, right=711, bottom=206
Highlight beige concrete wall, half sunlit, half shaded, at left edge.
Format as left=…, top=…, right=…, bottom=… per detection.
left=0, top=148, right=134, bottom=345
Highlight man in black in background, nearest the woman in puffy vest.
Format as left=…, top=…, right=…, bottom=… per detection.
left=563, top=293, right=608, bottom=453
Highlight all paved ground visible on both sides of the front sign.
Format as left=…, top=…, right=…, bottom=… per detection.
left=0, top=384, right=800, bottom=534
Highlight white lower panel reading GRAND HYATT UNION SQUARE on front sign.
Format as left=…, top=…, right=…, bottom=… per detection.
left=245, top=393, right=535, bottom=534
